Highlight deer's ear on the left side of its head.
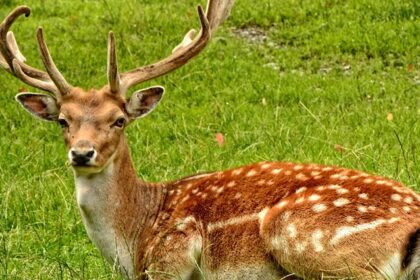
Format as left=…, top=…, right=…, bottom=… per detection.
left=15, top=92, right=59, bottom=121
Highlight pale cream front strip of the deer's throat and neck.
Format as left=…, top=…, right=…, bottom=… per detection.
left=75, top=162, right=134, bottom=278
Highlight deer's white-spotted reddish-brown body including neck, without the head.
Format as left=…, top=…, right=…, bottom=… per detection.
left=76, top=115, right=420, bottom=279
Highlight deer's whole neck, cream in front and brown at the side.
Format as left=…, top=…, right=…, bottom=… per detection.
left=75, top=138, right=164, bottom=276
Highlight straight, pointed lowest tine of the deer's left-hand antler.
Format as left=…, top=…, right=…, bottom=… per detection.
left=36, top=27, right=72, bottom=95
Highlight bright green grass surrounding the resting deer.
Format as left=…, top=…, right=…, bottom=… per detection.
left=0, top=0, right=420, bottom=279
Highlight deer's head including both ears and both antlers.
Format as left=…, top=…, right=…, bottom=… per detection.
left=0, top=0, right=233, bottom=173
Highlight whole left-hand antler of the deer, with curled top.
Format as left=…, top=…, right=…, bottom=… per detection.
left=0, top=6, right=71, bottom=100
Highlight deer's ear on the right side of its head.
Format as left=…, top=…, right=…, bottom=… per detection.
left=125, top=86, right=165, bottom=119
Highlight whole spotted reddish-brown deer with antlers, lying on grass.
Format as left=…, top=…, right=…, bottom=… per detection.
left=0, top=0, right=420, bottom=279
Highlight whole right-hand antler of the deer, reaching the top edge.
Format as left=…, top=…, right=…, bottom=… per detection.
left=108, top=0, right=233, bottom=95
